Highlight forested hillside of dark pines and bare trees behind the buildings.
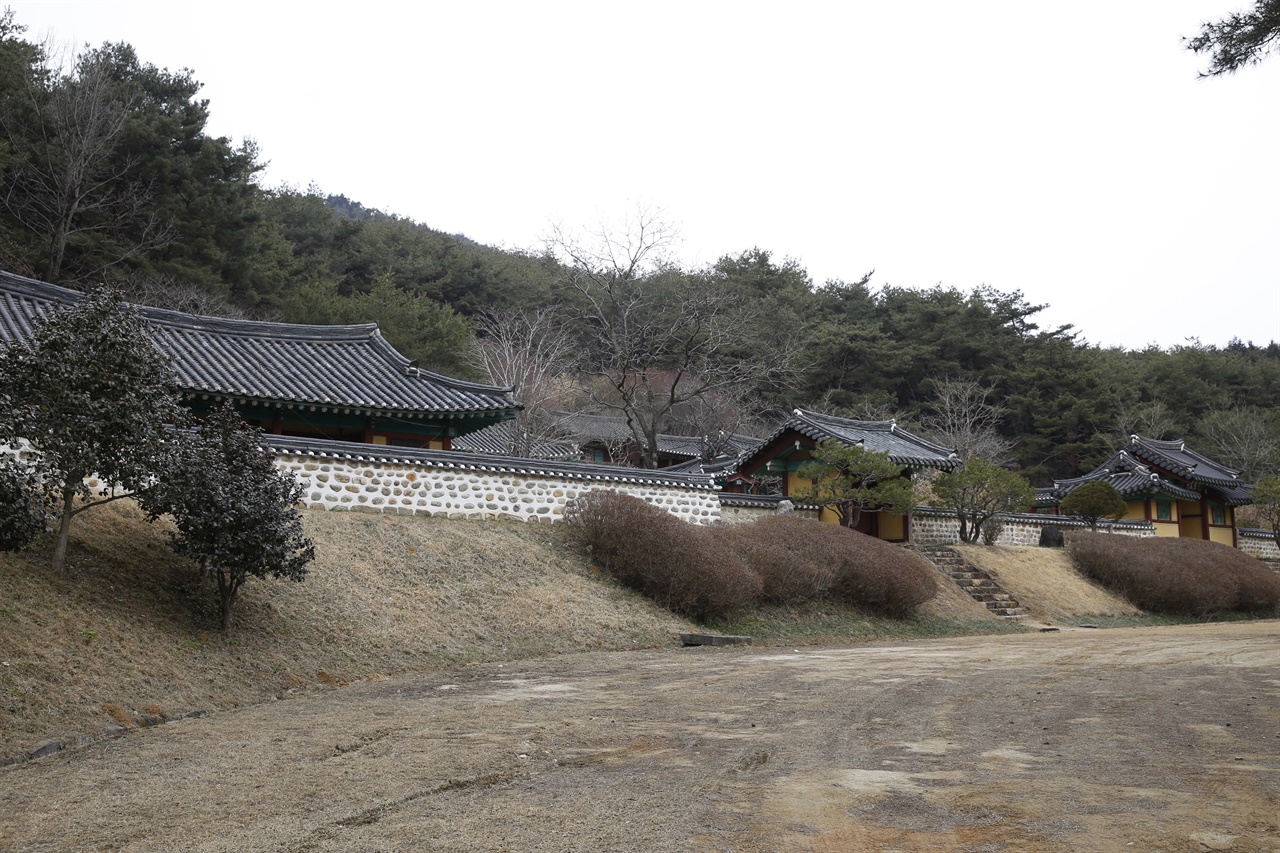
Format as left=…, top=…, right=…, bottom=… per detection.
left=0, top=12, right=1280, bottom=483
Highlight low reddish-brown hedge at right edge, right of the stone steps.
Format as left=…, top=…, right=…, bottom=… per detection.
left=1068, top=530, right=1280, bottom=616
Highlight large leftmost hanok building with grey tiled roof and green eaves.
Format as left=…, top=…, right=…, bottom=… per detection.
left=0, top=273, right=520, bottom=450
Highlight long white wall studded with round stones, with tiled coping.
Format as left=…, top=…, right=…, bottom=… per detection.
left=264, top=435, right=721, bottom=524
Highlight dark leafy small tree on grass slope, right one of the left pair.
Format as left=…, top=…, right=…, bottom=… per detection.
left=142, top=406, right=315, bottom=631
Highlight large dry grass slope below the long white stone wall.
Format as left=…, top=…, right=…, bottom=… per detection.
left=0, top=501, right=691, bottom=757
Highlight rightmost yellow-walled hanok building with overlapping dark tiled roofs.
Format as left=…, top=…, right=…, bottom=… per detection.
left=1036, top=435, right=1252, bottom=546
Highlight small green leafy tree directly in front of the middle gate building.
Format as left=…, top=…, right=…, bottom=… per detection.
left=796, top=438, right=915, bottom=528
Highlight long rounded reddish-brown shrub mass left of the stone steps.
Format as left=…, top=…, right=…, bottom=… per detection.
left=564, top=491, right=938, bottom=620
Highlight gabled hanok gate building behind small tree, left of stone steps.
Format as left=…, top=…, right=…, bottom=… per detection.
left=726, top=409, right=961, bottom=542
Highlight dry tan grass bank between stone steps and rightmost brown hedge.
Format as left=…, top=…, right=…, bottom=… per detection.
left=956, top=546, right=1142, bottom=621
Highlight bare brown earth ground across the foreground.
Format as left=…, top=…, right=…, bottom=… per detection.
left=0, top=621, right=1280, bottom=853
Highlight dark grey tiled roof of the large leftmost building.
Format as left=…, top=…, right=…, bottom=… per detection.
left=0, top=273, right=518, bottom=418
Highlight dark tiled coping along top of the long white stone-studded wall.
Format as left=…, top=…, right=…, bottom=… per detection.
left=261, top=434, right=716, bottom=491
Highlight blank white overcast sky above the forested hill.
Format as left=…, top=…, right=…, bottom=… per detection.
left=10, top=0, right=1280, bottom=348
